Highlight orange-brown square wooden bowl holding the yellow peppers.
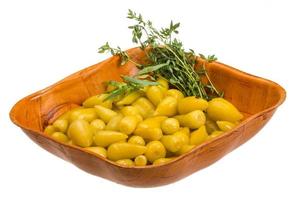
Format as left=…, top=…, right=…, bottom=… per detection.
left=10, top=48, right=285, bottom=187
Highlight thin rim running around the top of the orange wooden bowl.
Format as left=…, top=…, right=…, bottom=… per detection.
left=9, top=51, right=286, bottom=169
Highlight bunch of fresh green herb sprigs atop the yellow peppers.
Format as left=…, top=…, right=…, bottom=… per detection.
left=99, top=10, right=221, bottom=99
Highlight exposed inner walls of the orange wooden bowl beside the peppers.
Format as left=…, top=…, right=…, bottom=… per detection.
left=10, top=48, right=285, bottom=139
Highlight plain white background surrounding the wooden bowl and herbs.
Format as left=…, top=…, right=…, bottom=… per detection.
left=0, top=0, right=300, bottom=200
